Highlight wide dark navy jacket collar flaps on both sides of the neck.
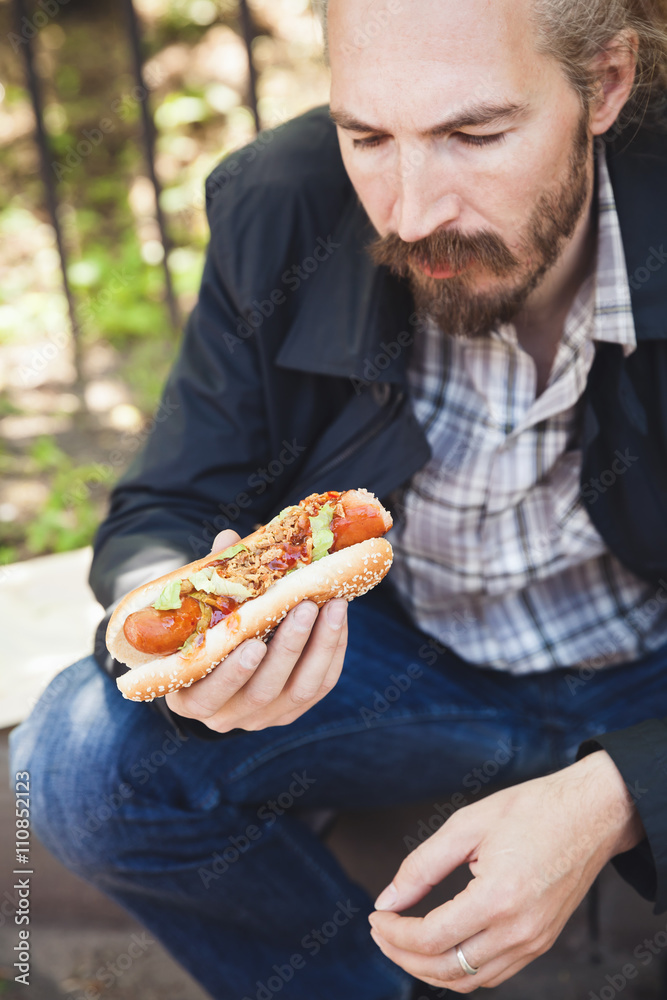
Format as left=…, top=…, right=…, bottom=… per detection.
left=276, top=114, right=667, bottom=385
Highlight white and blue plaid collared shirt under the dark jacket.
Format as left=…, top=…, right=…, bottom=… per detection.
left=387, top=155, right=667, bottom=674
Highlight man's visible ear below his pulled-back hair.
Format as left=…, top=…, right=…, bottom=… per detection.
left=590, top=31, right=639, bottom=135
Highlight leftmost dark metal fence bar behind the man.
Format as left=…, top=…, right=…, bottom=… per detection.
left=14, top=0, right=85, bottom=394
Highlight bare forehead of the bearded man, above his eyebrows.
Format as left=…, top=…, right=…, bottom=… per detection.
left=329, top=0, right=543, bottom=123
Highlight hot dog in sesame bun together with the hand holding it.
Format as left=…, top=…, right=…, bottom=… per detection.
left=106, top=489, right=392, bottom=708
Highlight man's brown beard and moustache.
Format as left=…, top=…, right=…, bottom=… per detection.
left=367, top=115, right=590, bottom=337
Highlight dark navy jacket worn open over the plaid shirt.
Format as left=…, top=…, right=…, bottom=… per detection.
left=90, top=108, right=667, bottom=906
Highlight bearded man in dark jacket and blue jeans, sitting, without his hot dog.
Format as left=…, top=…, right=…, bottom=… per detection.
left=12, top=0, right=667, bottom=1000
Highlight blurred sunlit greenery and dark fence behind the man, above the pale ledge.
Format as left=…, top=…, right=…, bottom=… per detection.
left=0, top=0, right=328, bottom=565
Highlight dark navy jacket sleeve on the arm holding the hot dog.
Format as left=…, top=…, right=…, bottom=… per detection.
left=89, top=195, right=280, bottom=738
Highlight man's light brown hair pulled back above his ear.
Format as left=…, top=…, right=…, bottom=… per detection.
left=312, top=0, right=667, bottom=124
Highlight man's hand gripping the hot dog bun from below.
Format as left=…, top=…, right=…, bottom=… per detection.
left=165, top=531, right=347, bottom=733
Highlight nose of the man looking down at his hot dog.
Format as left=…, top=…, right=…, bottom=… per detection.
left=391, top=154, right=462, bottom=243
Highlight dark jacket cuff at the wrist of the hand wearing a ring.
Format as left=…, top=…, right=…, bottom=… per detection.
left=577, top=719, right=667, bottom=914
